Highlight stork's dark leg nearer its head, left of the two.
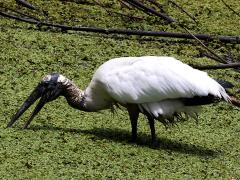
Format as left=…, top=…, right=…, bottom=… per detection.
left=127, top=104, right=139, bottom=142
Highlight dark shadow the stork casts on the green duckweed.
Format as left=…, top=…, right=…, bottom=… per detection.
left=30, top=125, right=222, bottom=158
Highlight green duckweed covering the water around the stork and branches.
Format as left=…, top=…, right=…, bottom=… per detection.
left=0, top=0, right=240, bottom=180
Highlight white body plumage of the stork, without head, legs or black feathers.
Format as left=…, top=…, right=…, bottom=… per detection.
left=85, top=56, right=228, bottom=118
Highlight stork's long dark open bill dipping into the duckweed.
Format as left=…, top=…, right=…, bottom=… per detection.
left=7, top=85, right=45, bottom=128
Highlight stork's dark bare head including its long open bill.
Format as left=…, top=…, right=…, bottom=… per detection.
left=7, top=73, right=69, bottom=128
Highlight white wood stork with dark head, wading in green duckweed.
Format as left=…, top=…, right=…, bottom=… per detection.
left=7, top=56, right=240, bottom=143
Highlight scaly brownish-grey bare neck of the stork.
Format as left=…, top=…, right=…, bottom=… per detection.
left=64, top=80, right=88, bottom=111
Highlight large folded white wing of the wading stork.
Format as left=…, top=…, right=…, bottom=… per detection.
left=92, top=56, right=227, bottom=103
